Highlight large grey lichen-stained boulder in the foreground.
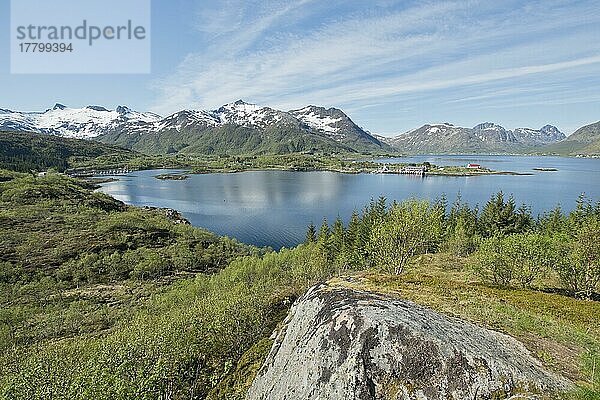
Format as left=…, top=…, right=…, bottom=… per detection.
left=247, top=284, right=571, bottom=400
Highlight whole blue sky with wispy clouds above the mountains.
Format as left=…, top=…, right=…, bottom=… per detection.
left=0, top=0, right=600, bottom=135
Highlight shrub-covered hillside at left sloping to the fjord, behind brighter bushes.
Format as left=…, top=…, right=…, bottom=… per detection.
left=0, top=171, right=256, bottom=356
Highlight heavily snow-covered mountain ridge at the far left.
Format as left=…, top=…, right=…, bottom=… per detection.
left=0, top=103, right=161, bottom=139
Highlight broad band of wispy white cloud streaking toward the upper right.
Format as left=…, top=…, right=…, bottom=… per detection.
left=154, top=0, right=600, bottom=120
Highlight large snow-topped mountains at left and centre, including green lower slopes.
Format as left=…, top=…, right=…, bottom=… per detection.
left=0, top=100, right=393, bottom=154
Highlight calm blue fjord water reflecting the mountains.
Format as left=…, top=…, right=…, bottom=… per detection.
left=100, top=155, right=600, bottom=249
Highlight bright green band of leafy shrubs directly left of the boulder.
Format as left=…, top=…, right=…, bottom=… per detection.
left=0, top=245, right=335, bottom=399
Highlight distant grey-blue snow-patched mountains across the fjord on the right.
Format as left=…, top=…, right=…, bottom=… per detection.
left=387, top=122, right=566, bottom=153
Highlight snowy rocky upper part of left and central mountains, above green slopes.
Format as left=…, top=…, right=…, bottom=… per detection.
left=0, top=100, right=388, bottom=154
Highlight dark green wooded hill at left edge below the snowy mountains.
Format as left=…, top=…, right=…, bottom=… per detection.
left=0, top=132, right=135, bottom=172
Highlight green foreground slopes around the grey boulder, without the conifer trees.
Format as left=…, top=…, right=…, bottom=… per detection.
left=0, top=172, right=600, bottom=399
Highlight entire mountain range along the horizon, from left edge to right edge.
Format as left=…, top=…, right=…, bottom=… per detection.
left=0, top=100, right=600, bottom=154
